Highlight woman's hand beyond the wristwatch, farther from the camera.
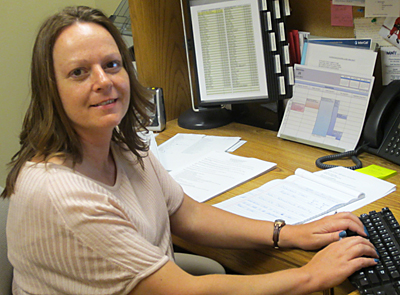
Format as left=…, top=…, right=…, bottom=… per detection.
left=279, top=212, right=366, bottom=250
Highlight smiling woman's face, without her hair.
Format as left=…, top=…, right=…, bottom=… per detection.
left=53, top=23, right=130, bottom=137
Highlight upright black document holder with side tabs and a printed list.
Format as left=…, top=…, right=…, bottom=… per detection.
left=188, top=0, right=287, bottom=106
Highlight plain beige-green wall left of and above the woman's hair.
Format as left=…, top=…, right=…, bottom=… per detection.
left=0, top=0, right=120, bottom=186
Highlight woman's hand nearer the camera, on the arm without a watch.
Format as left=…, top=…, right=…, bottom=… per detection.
left=301, top=236, right=379, bottom=290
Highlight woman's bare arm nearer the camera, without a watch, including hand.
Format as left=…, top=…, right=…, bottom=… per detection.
left=130, top=237, right=377, bottom=295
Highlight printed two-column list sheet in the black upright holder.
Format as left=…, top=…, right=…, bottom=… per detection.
left=190, top=0, right=268, bottom=102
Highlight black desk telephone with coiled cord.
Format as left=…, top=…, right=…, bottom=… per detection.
left=316, top=80, right=400, bottom=169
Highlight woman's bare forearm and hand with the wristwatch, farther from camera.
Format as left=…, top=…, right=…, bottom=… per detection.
left=170, top=196, right=365, bottom=250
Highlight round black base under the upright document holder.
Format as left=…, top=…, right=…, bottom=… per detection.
left=178, top=106, right=233, bottom=130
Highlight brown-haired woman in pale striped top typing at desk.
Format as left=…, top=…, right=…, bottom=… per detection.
left=2, top=7, right=377, bottom=295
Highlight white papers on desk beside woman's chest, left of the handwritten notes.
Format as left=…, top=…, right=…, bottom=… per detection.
left=158, top=134, right=276, bottom=202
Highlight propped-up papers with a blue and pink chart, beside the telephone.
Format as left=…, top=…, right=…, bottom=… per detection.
left=278, top=42, right=377, bottom=152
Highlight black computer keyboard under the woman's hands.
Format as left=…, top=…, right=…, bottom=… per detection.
left=349, top=208, right=400, bottom=295
